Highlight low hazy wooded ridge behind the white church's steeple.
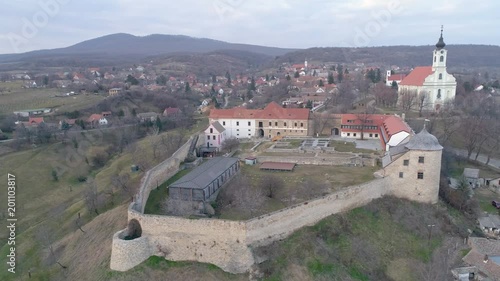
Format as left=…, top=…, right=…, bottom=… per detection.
left=275, top=45, right=500, bottom=68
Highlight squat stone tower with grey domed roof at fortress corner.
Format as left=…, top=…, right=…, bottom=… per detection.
left=384, top=126, right=443, bottom=204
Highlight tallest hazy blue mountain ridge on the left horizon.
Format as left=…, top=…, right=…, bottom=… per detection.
left=0, top=33, right=293, bottom=62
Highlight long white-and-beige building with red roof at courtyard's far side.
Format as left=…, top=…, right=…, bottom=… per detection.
left=209, top=102, right=309, bottom=138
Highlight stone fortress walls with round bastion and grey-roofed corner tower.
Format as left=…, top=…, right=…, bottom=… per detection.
left=110, top=127, right=443, bottom=273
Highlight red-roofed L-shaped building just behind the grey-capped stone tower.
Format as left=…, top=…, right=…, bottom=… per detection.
left=340, top=114, right=413, bottom=150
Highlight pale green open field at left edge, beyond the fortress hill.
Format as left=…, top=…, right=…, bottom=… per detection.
left=0, top=82, right=104, bottom=115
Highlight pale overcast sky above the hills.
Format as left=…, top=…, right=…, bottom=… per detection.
left=0, top=0, right=500, bottom=54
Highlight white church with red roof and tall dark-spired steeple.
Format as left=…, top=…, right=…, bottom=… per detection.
left=398, top=27, right=457, bottom=111
